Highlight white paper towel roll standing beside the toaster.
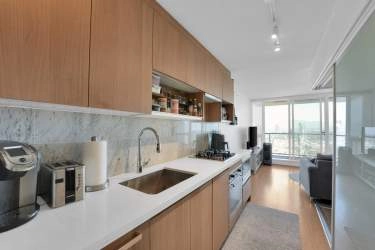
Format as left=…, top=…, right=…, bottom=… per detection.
left=82, top=137, right=107, bottom=187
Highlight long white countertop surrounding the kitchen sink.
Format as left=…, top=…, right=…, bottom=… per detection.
left=0, top=151, right=247, bottom=250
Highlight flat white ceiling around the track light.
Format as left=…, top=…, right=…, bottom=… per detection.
left=158, top=0, right=363, bottom=99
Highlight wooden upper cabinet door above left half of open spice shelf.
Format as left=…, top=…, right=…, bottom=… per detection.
left=152, top=11, right=188, bottom=82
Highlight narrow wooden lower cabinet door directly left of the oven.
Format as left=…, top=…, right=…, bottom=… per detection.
left=212, top=171, right=229, bottom=250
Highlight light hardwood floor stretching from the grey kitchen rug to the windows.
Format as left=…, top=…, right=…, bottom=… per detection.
left=251, top=165, right=329, bottom=250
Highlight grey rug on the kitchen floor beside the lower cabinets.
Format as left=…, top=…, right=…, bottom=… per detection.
left=222, top=203, right=301, bottom=250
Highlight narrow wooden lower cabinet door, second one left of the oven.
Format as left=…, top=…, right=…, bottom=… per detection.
left=190, top=182, right=212, bottom=250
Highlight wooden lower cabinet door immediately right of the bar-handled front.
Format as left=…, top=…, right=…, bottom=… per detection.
left=150, top=197, right=190, bottom=250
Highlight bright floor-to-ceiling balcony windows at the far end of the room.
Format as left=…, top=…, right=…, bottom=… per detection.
left=264, top=97, right=346, bottom=158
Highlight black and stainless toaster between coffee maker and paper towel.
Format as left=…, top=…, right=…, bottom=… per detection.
left=38, top=161, right=85, bottom=207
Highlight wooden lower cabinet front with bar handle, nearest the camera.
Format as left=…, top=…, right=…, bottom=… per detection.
left=103, top=222, right=150, bottom=250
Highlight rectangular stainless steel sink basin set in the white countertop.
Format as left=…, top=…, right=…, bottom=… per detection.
left=120, top=169, right=196, bottom=194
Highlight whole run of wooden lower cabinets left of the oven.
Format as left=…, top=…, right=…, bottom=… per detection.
left=104, top=170, right=230, bottom=250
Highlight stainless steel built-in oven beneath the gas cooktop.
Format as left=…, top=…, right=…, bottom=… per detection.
left=229, top=164, right=242, bottom=228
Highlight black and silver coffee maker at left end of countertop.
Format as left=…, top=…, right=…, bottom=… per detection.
left=0, top=141, right=40, bottom=233
